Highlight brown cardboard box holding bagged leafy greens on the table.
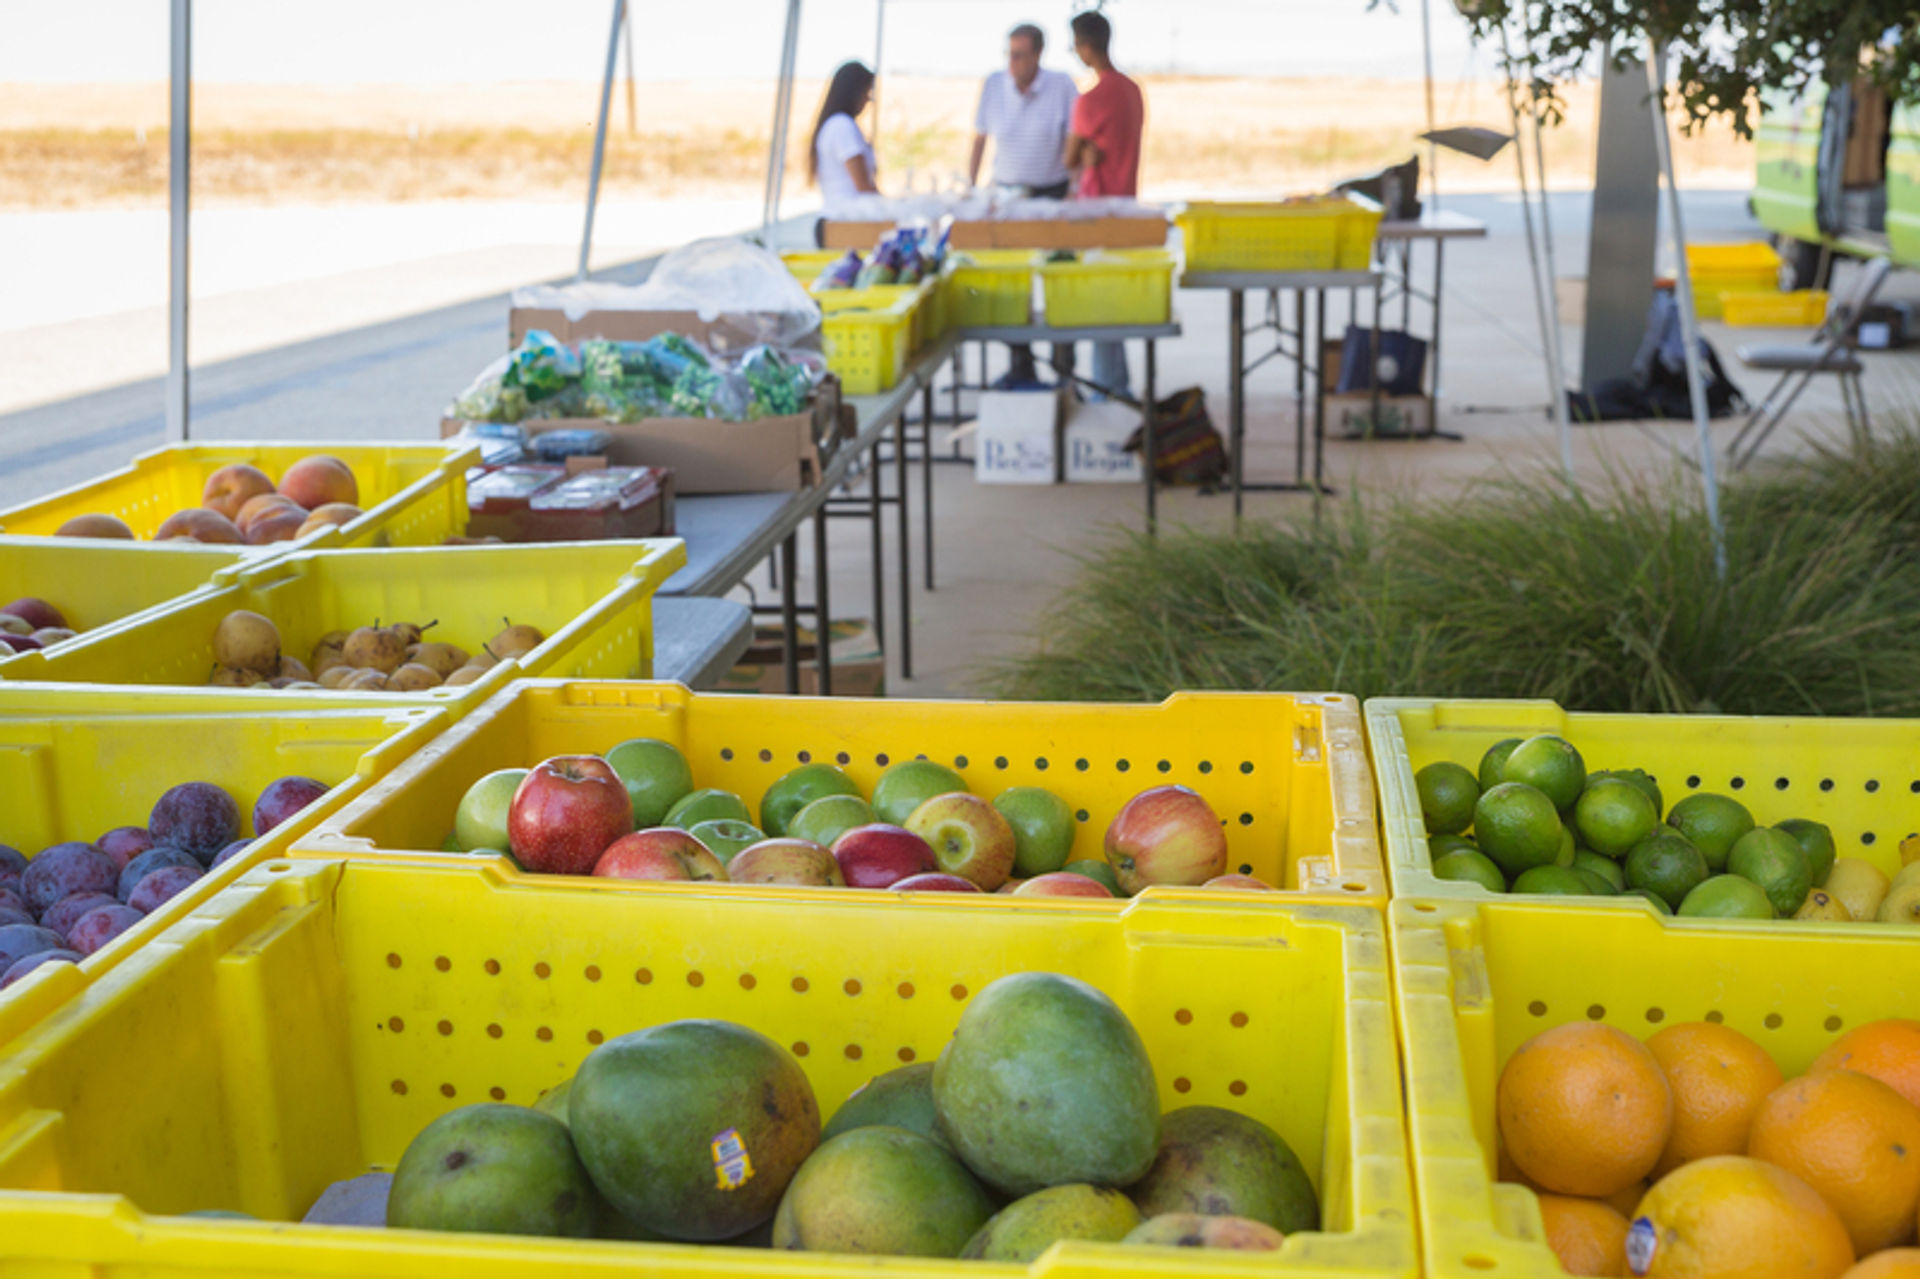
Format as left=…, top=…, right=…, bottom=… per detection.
left=440, top=376, right=843, bottom=495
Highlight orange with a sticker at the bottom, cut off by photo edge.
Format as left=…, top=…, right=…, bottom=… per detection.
left=1626, top=1154, right=1853, bottom=1279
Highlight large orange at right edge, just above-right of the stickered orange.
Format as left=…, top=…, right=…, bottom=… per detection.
left=1747, top=1070, right=1920, bottom=1256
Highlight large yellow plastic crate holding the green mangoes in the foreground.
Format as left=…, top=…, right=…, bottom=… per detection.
left=0, top=860, right=1417, bottom=1279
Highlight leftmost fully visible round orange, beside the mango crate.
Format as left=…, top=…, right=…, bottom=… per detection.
left=1494, top=1022, right=1674, bottom=1198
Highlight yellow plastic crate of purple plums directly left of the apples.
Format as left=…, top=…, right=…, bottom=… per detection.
left=0, top=686, right=445, bottom=1045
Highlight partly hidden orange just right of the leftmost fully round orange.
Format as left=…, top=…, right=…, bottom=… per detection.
left=1647, top=1022, right=1782, bottom=1177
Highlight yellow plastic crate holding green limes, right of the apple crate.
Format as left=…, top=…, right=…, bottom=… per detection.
left=1367, top=697, right=1920, bottom=925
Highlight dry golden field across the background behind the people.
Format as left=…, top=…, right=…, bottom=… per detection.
left=0, top=77, right=1753, bottom=209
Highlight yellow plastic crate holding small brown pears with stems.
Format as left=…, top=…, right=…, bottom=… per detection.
left=0, top=538, right=687, bottom=712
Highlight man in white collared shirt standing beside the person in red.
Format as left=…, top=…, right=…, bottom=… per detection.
left=966, top=23, right=1079, bottom=382
